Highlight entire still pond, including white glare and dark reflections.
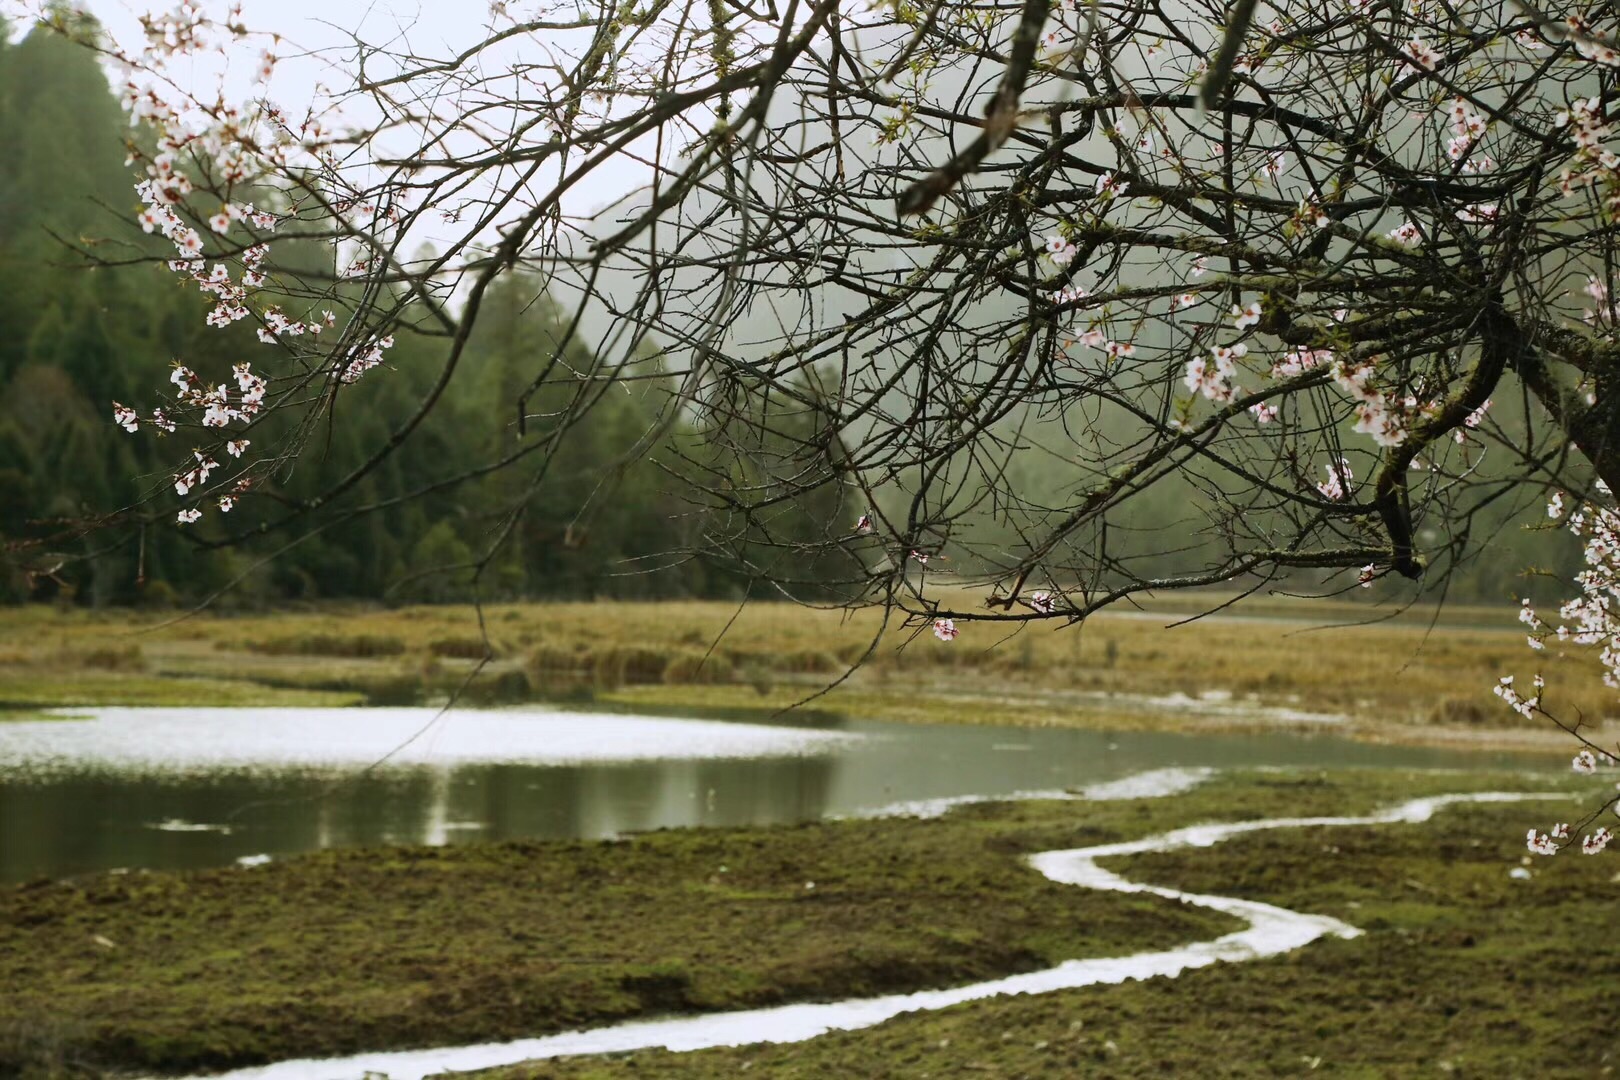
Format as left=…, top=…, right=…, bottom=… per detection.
left=0, top=708, right=1539, bottom=881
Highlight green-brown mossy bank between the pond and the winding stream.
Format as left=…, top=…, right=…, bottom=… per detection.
left=0, top=771, right=1607, bottom=1077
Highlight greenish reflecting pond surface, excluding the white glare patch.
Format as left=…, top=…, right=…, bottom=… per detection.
left=0, top=725, right=1520, bottom=881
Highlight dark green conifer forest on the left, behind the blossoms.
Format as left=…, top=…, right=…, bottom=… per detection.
left=0, top=12, right=860, bottom=606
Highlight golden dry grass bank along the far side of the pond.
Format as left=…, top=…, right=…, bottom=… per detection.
left=0, top=596, right=1617, bottom=751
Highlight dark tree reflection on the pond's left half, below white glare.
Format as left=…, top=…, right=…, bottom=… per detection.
left=0, top=758, right=836, bottom=881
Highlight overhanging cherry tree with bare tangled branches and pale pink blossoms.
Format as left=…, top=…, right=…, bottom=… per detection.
left=19, top=0, right=1620, bottom=850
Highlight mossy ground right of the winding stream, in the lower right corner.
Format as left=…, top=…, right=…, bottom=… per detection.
left=484, top=777, right=1620, bottom=1080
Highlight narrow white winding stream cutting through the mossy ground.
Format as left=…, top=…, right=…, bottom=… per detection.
left=180, top=792, right=1565, bottom=1080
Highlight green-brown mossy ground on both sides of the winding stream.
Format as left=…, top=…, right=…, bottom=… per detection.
left=0, top=771, right=1594, bottom=1077
